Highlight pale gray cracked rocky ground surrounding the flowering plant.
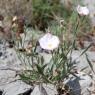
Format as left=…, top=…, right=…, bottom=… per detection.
left=0, top=28, right=95, bottom=95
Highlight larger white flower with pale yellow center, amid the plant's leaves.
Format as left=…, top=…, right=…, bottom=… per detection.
left=39, top=33, right=60, bottom=50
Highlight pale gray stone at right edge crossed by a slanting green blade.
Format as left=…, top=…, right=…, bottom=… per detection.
left=68, top=50, right=95, bottom=73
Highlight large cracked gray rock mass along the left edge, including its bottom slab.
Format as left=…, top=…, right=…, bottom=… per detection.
left=0, top=42, right=33, bottom=95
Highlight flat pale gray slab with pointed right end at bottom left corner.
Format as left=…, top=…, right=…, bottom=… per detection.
left=3, top=80, right=32, bottom=95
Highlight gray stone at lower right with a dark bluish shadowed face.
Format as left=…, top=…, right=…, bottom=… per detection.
left=65, top=72, right=93, bottom=95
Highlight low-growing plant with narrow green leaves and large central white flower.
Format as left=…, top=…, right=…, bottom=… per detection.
left=12, top=1, right=93, bottom=95
